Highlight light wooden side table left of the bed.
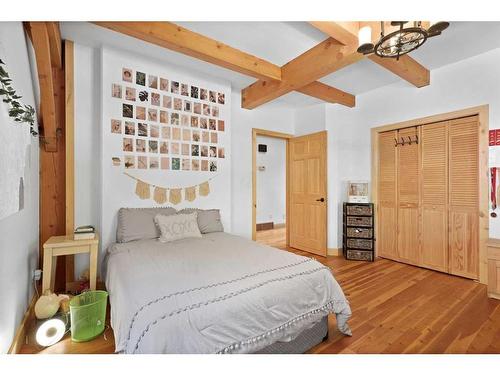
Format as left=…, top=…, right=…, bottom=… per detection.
left=42, top=233, right=99, bottom=293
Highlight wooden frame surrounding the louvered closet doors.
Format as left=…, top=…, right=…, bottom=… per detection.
left=371, top=104, right=489, bottom=284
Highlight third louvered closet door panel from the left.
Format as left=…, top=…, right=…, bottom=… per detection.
left=420, top=121, right=448, bottom=272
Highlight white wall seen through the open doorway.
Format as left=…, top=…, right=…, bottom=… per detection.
left=255, top=136, right=286, bottom=224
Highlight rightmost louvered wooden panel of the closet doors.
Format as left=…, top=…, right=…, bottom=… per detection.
left=448, top=116, right=479, bottom=279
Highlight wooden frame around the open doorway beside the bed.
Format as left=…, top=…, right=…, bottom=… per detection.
left=252, top=128, right=294, bottom=242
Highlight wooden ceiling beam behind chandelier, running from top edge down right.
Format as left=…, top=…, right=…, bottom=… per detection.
left=310, top=21, right=430, bottom=87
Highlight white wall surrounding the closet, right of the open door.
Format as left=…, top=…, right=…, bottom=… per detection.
left=326, top=49, right=500, bottom=247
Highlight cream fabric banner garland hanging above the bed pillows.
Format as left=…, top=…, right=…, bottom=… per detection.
left=124, top=172, right=214, bottom=205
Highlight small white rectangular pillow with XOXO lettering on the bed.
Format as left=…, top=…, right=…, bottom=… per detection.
left=155, top=212, right=201, bottom=242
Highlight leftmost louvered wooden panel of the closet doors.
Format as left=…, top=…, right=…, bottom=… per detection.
left=377, top=131, right=398, bottom=259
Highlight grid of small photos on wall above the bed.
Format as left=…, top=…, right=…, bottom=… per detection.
left=110, top=68, right=227, bottom=172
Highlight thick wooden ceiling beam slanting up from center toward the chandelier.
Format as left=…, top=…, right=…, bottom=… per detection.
left=241, top=38, right=363, bottom=109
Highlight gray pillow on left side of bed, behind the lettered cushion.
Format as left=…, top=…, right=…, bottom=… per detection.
left=116, top=207, right=177, bottom=242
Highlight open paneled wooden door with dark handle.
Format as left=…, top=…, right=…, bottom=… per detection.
left=289, top=131, right=327, bottom=256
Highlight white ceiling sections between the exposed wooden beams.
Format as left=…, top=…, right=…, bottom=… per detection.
left=60, top=22, right=500, bottom=107
